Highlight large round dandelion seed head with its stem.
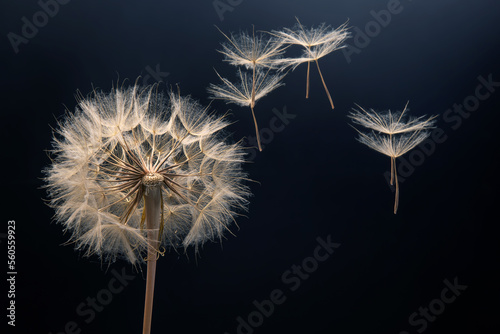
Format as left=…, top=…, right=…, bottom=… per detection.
left=45, top=82, right=249, bottom=333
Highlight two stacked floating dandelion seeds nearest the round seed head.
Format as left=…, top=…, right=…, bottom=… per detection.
left=213, top=28, right=285, bottom=151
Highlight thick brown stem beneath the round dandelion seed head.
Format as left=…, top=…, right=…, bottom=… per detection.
left=142, top=186, right=161, bottom=334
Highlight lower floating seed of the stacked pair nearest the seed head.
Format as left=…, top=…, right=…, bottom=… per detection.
left=208, top=69, right=285, bottom=151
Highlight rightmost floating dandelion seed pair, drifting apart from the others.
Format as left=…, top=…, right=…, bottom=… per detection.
left=349, top=103, right=436, bottom=214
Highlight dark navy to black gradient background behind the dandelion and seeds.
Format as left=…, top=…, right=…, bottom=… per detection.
left=0, top=0, right=500, bottom=334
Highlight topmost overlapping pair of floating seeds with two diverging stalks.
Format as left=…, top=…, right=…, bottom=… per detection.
left=271, top=18, right=350, bottom=109
